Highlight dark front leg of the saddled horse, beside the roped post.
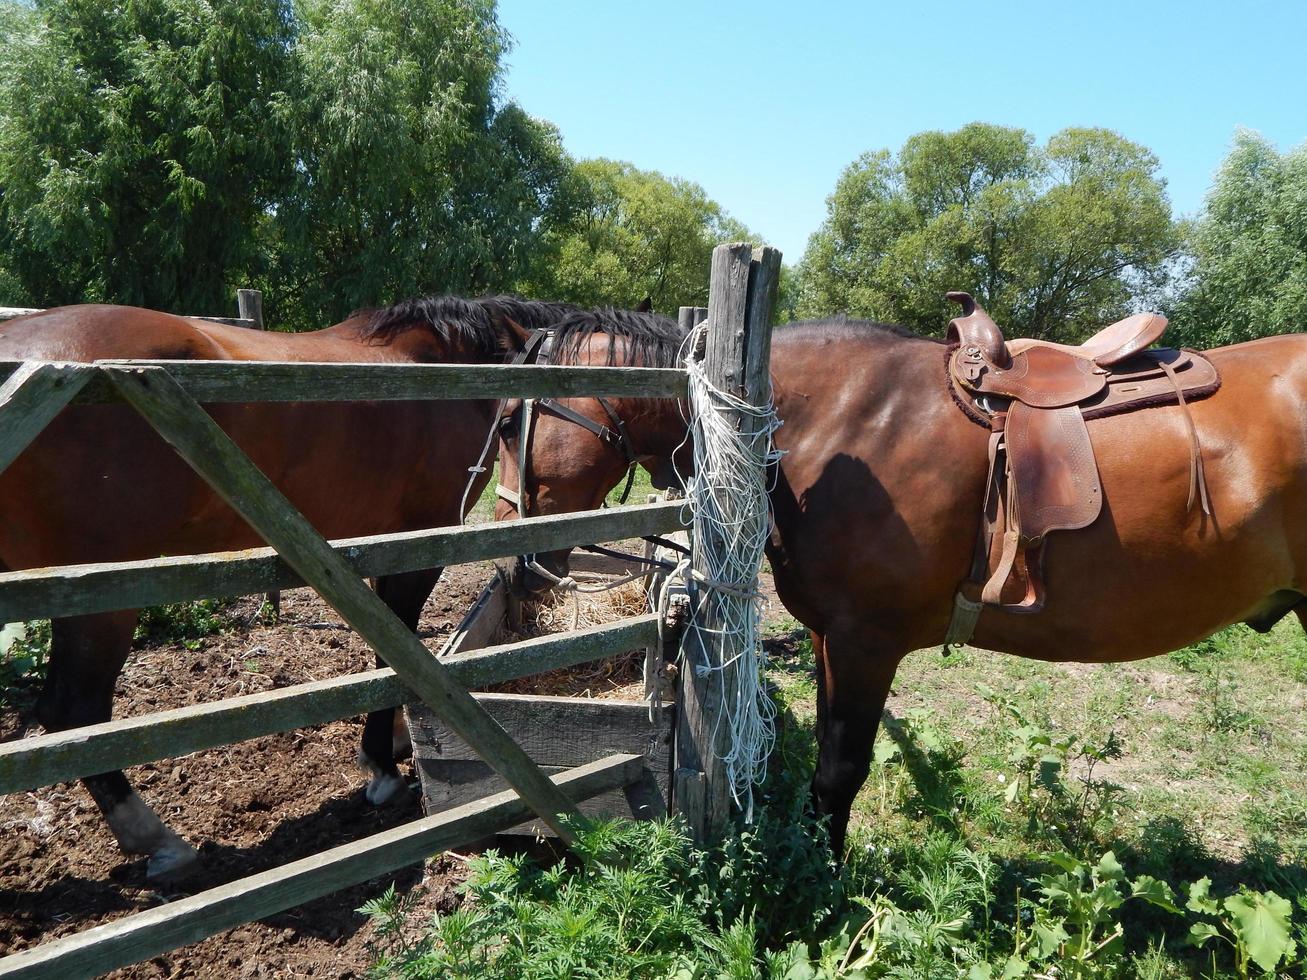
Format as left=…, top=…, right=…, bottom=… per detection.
left=813, top=629, right=902, bottom=860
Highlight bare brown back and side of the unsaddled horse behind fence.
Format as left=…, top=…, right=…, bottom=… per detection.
left=0, top=306, right=489, bottom=568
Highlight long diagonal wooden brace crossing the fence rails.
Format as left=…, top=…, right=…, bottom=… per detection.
left=109, top=366, right=578, bottom=844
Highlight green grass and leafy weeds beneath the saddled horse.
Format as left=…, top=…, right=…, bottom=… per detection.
left=371, top=619, right=1307, bottom=980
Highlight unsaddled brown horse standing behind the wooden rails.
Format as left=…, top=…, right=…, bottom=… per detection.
left=0, top=298, right=582, bottom=877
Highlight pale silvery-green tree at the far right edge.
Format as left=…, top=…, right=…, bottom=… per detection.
left=1174, top=131, right=1307, bottom=346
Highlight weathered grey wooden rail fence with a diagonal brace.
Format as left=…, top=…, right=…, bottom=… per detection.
left=0, top=246, right=779, bottom=977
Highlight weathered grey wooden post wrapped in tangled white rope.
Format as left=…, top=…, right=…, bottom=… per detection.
left=672, top=243, right=780, bottom=841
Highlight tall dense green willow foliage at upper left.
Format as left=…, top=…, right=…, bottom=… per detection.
left=0, top=0, right=585, bottom=328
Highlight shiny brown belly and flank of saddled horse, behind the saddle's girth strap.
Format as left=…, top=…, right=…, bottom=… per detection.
left=975, top=366, right=1307, bottom=662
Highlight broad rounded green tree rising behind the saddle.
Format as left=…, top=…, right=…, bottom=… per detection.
left=799, top=123, right=1178, bottom=341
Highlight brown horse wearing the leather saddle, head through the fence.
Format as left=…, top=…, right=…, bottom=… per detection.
left=499, top=303, right=1307, bottom=855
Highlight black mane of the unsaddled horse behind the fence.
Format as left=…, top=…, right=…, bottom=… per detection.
left=352, top=295, right=582, bottom=354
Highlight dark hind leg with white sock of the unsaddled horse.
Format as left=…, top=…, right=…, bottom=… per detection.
left=37, top=612, right=199, bottom=878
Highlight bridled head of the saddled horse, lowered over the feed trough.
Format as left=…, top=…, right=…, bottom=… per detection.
left=495, top=310, right=685, bottom=597
